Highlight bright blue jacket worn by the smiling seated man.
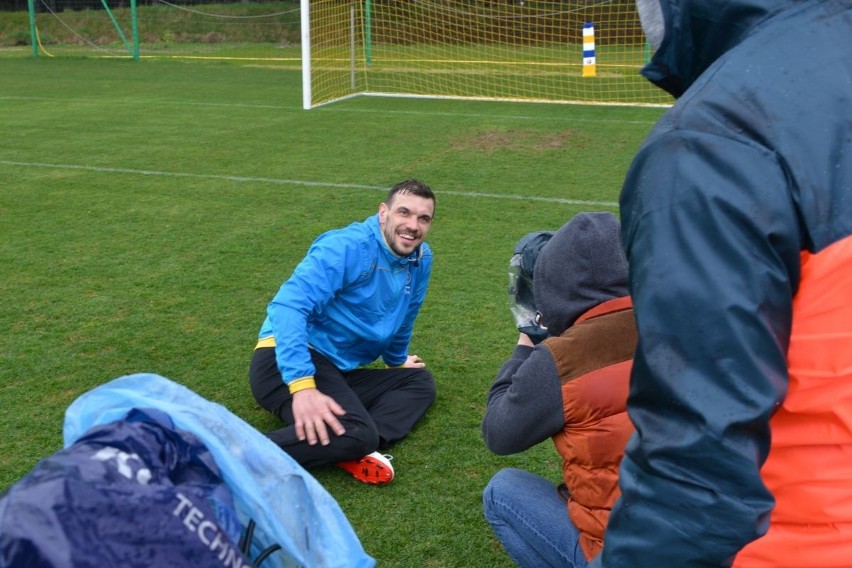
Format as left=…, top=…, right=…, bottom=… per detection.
left=259, top=215, right=432, bottom=385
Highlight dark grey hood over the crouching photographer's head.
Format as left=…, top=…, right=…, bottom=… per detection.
left=533, top=212, right=629, bottom=336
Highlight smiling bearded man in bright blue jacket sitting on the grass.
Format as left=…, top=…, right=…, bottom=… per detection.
left=249, top=180, right=435, bottom=485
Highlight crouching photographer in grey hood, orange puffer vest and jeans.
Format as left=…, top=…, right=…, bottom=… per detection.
left=482, top=213, right=637, bottom=568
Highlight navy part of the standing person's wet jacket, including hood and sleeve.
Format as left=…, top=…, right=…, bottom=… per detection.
left=591, top=0, right=852, bottom=568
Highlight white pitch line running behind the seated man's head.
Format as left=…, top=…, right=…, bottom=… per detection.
left=0, top=160, right=618, bottom=209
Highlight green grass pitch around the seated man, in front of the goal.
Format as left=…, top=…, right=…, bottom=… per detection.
left=0, top=54, right=662, bottom=567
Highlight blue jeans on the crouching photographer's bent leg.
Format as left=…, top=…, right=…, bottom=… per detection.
left=482, top=468, right=586, bottom=568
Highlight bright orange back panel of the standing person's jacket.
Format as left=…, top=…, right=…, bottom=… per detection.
left=734, top=237, right=852, bottom=568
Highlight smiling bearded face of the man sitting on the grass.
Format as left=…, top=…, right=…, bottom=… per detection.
left=379, top=193, right=435, bottom=256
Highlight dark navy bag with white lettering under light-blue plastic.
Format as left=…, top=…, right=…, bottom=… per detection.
left=0, top=409, right=249, bottom=568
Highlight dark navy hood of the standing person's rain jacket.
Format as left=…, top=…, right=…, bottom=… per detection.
left=637, top=0, right=792, bottom=97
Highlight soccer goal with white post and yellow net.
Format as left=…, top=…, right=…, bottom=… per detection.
left=302, top=0, right=673, bottom=108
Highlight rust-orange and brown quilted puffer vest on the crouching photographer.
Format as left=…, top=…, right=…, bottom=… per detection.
left=544, top=297, right=636, bottom=559
